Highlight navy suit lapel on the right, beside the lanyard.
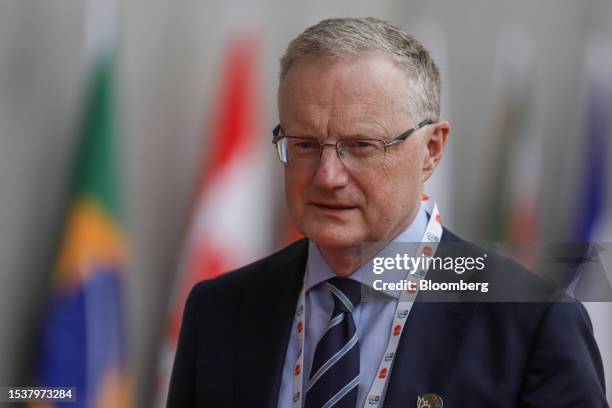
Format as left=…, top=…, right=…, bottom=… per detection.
left=384, top=230, right=477, bottom=407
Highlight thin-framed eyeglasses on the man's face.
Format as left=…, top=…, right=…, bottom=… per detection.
left=272, top=119, right=434, bottom=169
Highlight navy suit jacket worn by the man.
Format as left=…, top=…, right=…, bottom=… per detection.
left=168, top=230, right=608, bottom=408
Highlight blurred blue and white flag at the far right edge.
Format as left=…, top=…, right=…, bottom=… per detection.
left=569, top=36, right=612, bottom=400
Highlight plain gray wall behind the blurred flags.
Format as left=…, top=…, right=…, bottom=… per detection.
left=0, top=0, right=612, bottom=407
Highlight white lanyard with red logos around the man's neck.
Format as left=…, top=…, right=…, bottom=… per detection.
left=291, top=194, right=442, bottom=408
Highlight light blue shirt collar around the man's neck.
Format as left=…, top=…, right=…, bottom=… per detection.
left=306, top=205, right=428, bottom=298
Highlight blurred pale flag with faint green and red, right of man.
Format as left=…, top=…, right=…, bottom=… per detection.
left=485, top=30, right=542, bottom=266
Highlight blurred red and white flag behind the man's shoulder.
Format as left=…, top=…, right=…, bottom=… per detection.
left=157, top=34, right=274, bottom=406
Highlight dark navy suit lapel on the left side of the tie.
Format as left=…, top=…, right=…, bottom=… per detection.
left=234, top=240, right=308, bottom=408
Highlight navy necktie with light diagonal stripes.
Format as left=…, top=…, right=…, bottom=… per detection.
left=305, top=278, right=361, bottom=408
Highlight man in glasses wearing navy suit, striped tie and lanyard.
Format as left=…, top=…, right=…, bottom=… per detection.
left=168, top=18, right=606, bottom=408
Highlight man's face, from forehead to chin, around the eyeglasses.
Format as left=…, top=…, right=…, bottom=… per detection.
left=279, top=56, right=429, bottom=249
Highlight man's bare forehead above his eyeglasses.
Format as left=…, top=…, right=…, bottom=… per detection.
left=278, top=55, right=408, bottom=130
